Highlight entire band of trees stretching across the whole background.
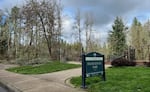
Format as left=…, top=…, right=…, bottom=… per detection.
left=0, top=0, right=150, bottom=61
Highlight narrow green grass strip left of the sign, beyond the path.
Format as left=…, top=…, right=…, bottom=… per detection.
left=7, top=62, right=81, bottom=74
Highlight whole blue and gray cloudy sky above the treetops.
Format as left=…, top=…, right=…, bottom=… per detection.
left=0, top=0, right=150, bottom=42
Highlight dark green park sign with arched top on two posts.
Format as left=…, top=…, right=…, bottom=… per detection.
left=82, top=52, right=105, bottom=88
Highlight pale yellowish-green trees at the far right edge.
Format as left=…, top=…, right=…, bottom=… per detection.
left=130, top=17, right=150, bottom=60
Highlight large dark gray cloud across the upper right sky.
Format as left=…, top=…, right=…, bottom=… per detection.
left=62, top=0, right=150, bottom=25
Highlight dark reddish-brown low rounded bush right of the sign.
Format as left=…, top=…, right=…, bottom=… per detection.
left=111, top=58, right=136, bottom=67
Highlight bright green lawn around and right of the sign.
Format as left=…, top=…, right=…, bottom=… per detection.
left=71, top=67, right=150, bottom=92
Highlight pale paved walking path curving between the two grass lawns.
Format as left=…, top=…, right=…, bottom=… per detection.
left=0, top=64, right=110, bottom=92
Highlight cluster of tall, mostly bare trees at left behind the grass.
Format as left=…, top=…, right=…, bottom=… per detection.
left=0, top=0, right=62, bottom=60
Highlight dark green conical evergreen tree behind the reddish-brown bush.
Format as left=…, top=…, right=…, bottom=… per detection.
left=108, top=17, right=126, bottom=56
